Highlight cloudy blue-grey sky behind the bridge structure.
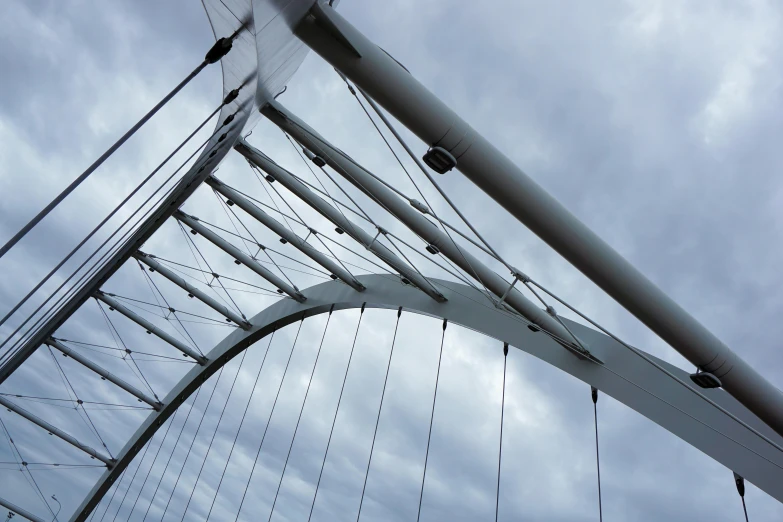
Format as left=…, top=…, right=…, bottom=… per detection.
left=0, top=0, right=783, bottom=521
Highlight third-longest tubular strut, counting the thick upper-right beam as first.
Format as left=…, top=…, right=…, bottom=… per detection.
left=234, top=139, right=446, bottom=302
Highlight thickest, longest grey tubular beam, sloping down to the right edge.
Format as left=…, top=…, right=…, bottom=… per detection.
left=295, top=3, right=783, bottom=435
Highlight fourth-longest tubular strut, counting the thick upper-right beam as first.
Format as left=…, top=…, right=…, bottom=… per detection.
left=206, top=176, right=364, bottom=292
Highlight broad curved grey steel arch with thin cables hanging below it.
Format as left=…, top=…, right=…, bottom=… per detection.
left=71, top=275, right=783, bottom=522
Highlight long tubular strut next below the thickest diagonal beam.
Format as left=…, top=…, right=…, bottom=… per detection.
left=261, top=102, right=583, bottom=350
